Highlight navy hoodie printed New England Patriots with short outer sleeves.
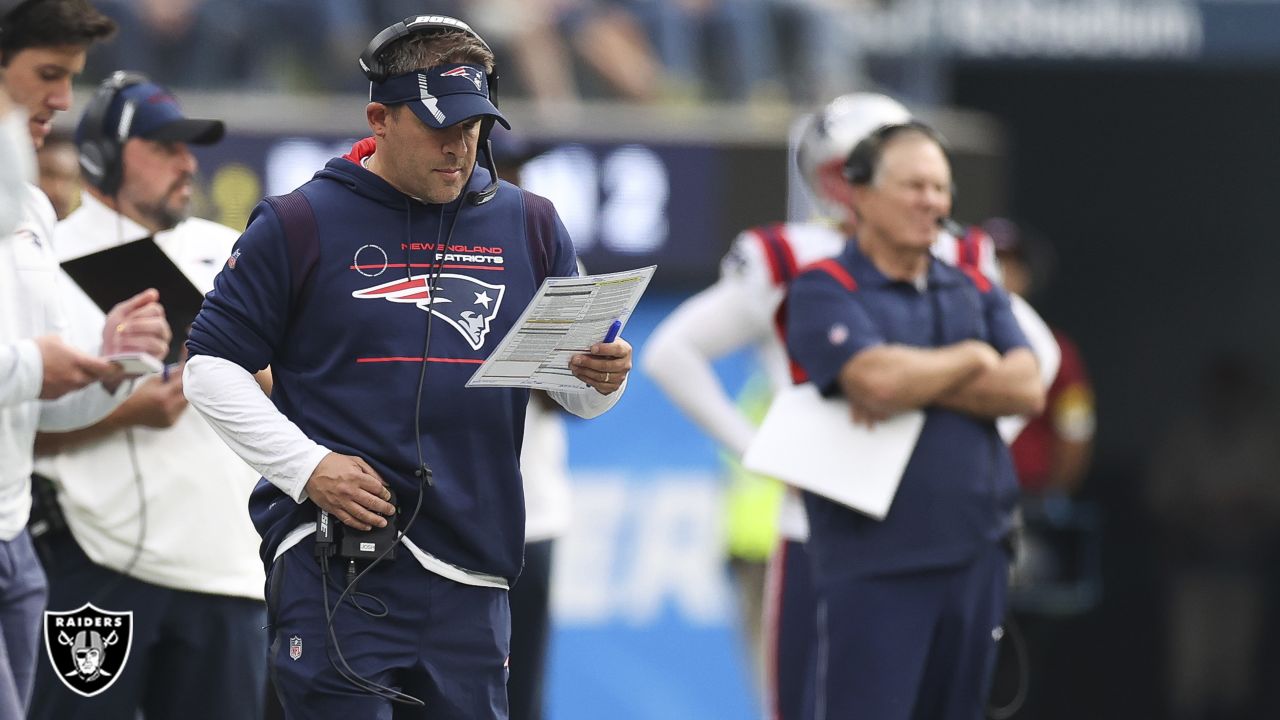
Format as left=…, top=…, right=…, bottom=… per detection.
left=188, top=140, right=577, bottom=582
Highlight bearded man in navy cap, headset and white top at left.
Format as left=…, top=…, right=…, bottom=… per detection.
left=31, top=72, right=266, bottom=720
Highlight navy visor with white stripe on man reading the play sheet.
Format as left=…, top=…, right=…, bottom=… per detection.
left=369, top=63, right=511, bottom=129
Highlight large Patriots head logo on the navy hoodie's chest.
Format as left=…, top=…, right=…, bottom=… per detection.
left=351, top=273, right=507, bottom=350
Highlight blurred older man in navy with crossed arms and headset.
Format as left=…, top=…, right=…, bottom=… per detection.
left=783, top=122, right=1044, bottom=720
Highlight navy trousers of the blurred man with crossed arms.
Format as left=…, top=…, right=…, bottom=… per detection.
left=814, top=544, right=1009, bottom=720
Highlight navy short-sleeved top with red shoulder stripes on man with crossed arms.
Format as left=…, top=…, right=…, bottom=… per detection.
left=786, top=240, right=1027, bottom=585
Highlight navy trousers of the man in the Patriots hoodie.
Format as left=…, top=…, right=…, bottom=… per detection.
left=268, top=538, right=511, bottom=720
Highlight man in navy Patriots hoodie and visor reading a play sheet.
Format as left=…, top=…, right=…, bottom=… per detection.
left=184, top=15, right=631, bottom=719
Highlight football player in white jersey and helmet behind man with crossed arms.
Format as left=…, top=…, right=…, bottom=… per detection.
left=640, top=94, right=1056, bottom=719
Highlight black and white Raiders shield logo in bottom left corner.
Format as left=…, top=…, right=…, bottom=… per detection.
left=45, top=602, right=133, bottom=697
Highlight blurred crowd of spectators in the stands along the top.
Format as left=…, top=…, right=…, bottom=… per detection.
left=86, top=0, right=874, bottom=105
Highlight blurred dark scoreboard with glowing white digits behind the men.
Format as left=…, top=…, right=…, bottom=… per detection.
left=192, top=110, right=1005, bottom=290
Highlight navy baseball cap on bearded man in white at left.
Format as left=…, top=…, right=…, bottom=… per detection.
left=76, top=82, right=227, bottom=145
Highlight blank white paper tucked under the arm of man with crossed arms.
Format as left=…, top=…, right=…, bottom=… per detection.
left=742, top=383, right=924, bottom=520
